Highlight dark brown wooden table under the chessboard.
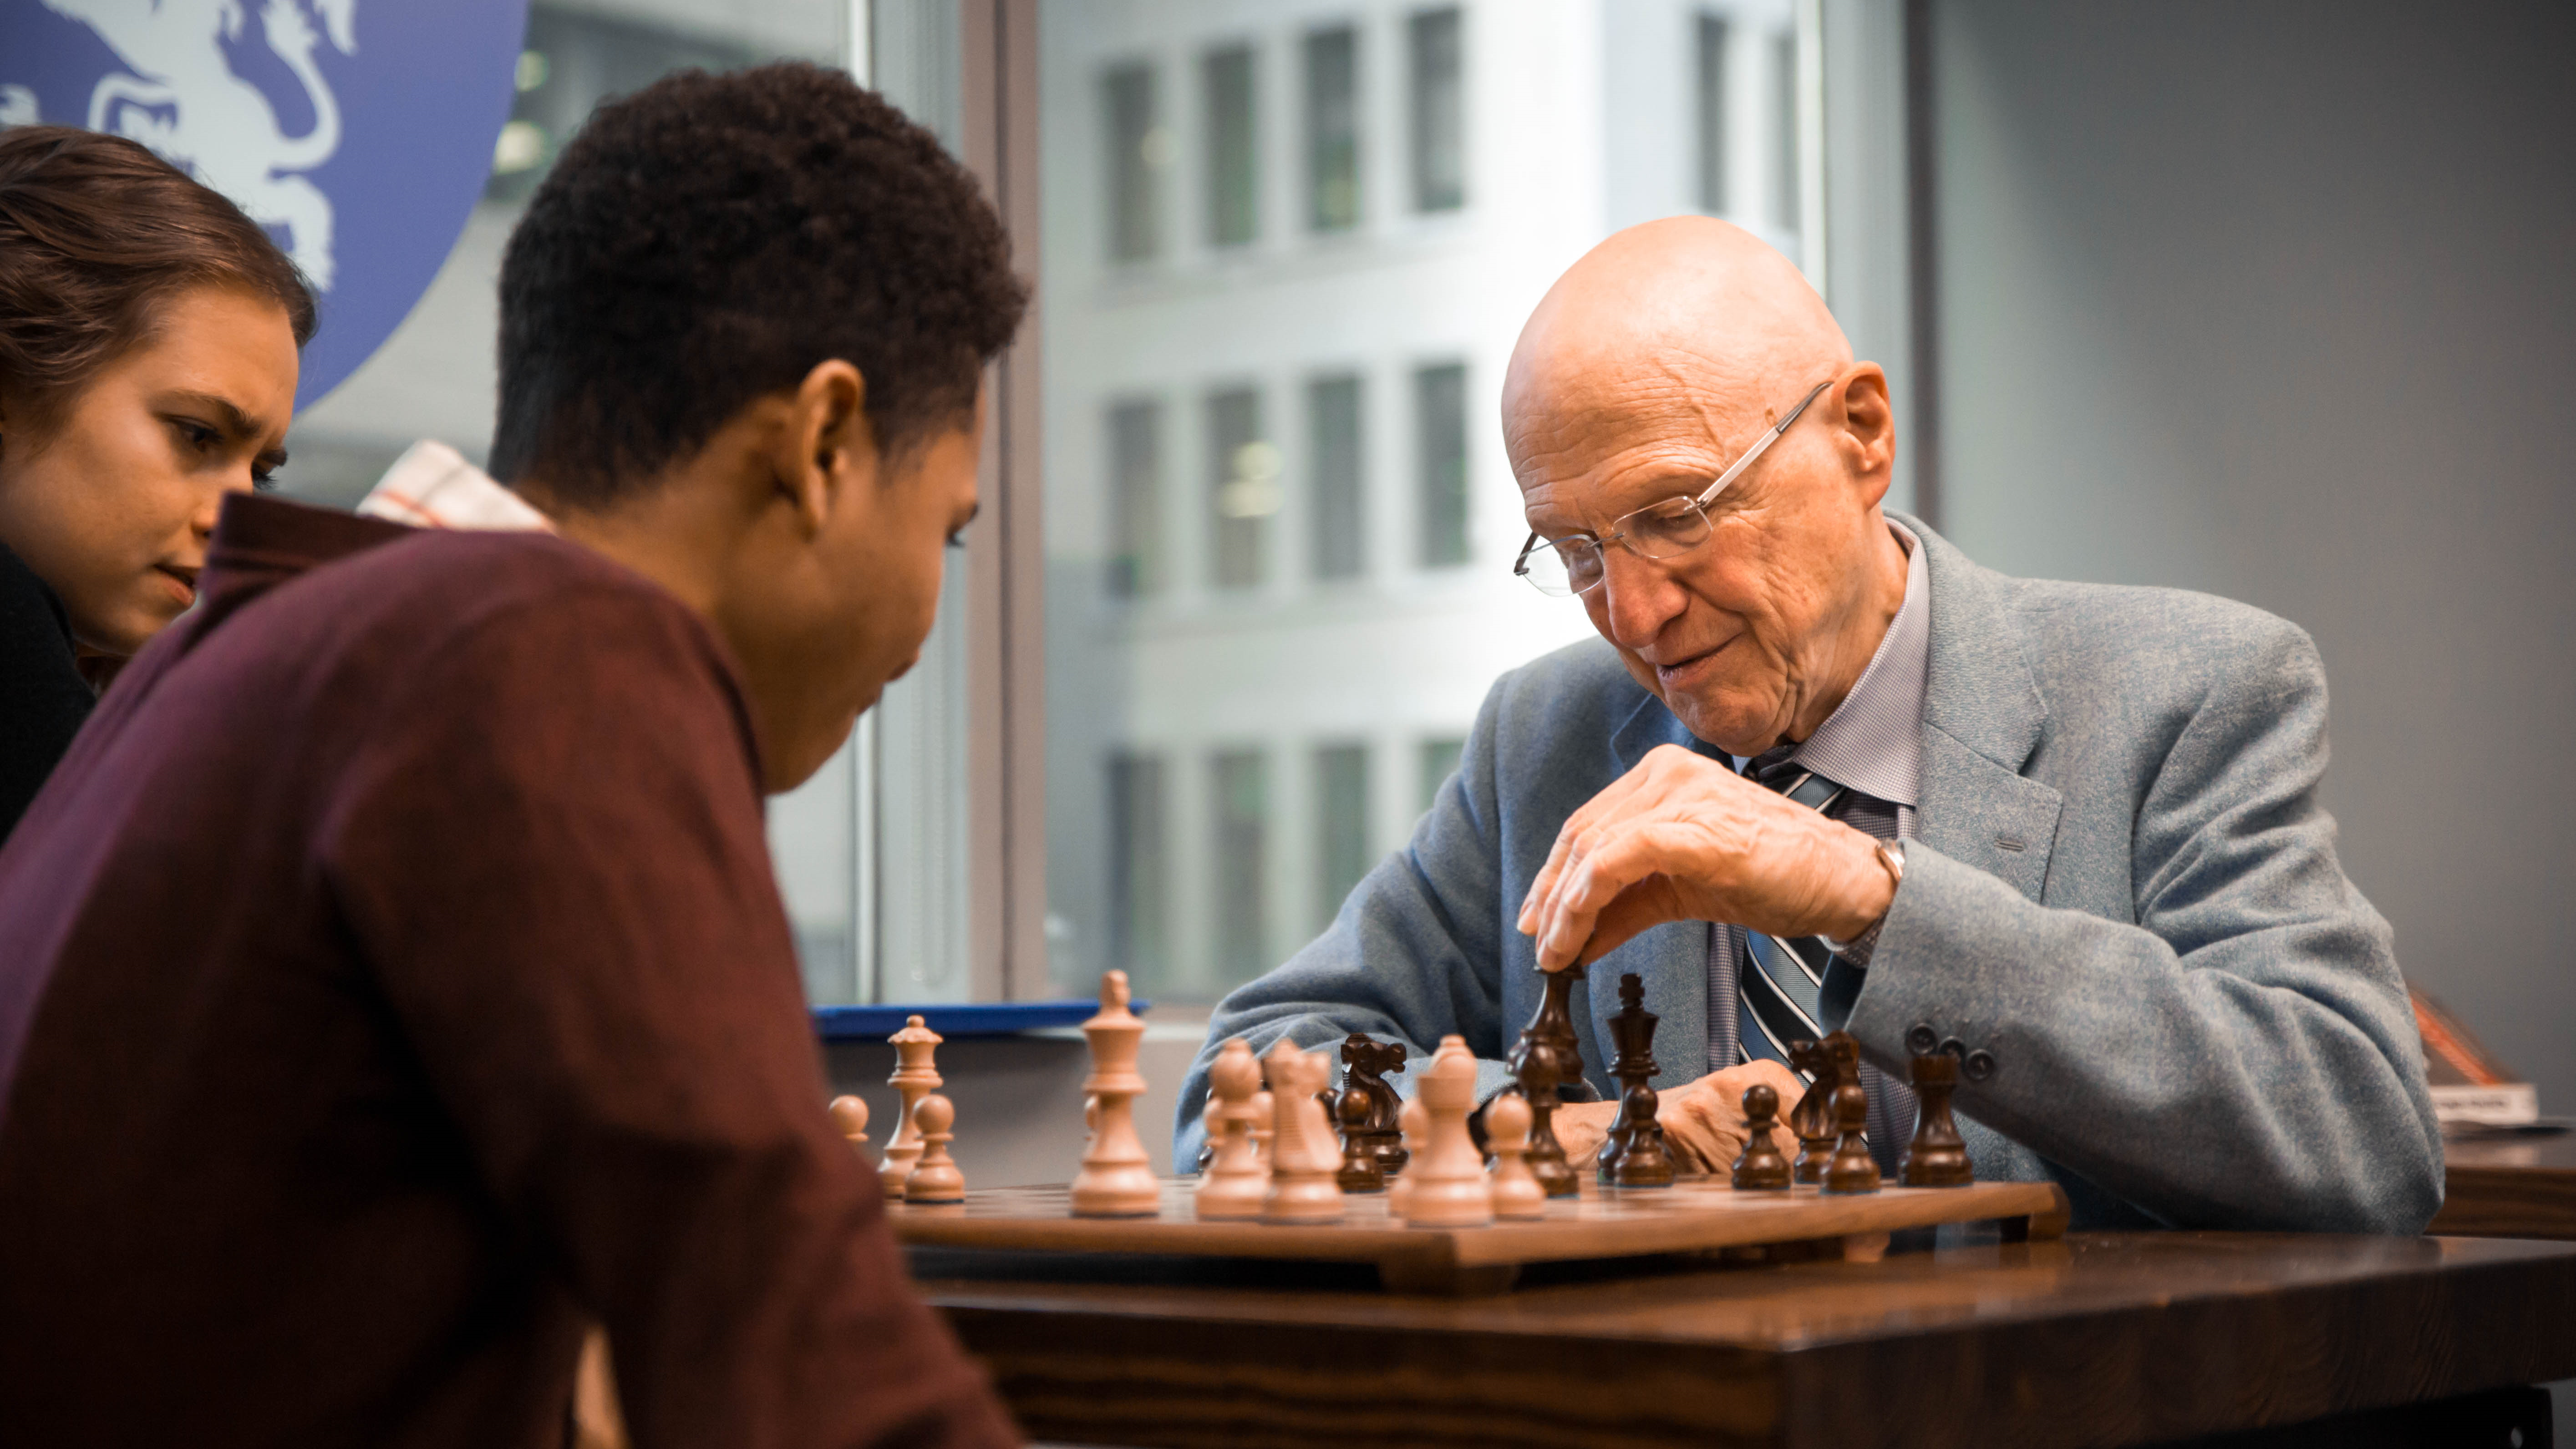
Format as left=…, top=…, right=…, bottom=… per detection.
left=915, top=1230, right=2576, bottom=1449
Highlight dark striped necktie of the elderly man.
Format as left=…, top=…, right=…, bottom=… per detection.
left=1736, top=745, right=1914, bottom=1170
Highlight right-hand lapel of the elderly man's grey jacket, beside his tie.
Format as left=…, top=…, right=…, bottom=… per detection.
left=1901, top=518, right=2063, bottom=900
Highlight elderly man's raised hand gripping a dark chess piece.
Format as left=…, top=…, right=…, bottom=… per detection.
left=1520, top=745, right=1896, bottom=972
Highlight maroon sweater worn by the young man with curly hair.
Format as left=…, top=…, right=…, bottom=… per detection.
left=0, top=498, right=1015, bottom=1449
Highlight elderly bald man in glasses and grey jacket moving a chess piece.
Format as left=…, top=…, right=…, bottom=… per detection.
left=1177, top=219, right=2442, bottom=1232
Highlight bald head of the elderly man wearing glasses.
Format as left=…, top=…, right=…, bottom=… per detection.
left=1502, top=217, right=1906, bottom=755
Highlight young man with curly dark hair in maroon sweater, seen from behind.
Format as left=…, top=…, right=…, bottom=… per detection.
left=0, top=67, right=1025, bottom=1449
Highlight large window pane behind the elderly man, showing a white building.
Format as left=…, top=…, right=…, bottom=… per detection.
left=1038, top=0, right=1798, bottom=1001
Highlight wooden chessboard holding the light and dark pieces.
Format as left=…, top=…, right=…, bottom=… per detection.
left=886, top=1178, right=2066, bottom=1294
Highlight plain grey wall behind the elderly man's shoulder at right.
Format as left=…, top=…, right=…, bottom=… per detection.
left=1919, top=0, right=2576, bottom=1114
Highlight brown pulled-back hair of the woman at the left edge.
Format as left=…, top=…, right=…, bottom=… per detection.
left=0, top=127, right=314, bottom=436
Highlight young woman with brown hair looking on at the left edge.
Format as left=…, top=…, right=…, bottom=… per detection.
left=0, top=127, right=314, bottom=838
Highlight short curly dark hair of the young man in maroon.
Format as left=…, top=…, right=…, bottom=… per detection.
left=492, top=62, right=1028, bottom=508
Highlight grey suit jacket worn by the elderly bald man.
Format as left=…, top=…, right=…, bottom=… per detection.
left=1175, top=518, right=2442, bottom=1232
